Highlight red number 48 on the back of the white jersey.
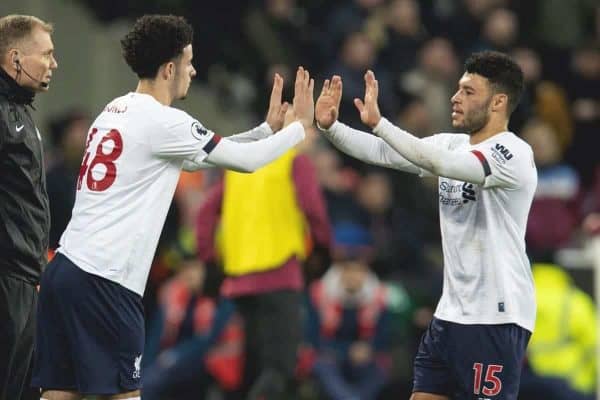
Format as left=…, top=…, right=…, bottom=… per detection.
left=77, top=128, right=123, bottom=192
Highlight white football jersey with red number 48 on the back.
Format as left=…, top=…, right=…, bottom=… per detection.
left=58, top=93, right=219, bottom=295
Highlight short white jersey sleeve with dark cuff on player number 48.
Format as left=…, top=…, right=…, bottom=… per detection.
left=150, top=108, right=221, bottom=162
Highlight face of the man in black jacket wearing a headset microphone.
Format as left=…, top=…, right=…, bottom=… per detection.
left=14, top=28, right=58, bottom=92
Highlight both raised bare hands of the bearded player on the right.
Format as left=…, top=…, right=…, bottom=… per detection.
left=315, top=70, right=381, bottom=129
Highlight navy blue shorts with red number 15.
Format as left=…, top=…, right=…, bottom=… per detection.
left=413, top=318, right=531, bottom=400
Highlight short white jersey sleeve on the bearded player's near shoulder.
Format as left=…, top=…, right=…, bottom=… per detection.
left=471, top=141, right=535, bottom=189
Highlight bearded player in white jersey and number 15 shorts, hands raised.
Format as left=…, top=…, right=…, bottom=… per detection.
left=315, top=52, right=537, bottom=400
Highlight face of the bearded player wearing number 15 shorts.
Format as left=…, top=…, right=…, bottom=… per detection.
left=450, top=72, right=492, bottom=134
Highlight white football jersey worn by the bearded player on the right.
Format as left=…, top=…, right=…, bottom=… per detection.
left=428, top=132, right=537, bottom=331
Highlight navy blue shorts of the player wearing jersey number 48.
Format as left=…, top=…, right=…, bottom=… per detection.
left=32, top=253, right=144, bottom=395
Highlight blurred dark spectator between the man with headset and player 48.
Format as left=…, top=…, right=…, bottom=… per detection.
left=46, top=109, right=91, bottom=249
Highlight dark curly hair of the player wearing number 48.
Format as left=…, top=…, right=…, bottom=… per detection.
left=121, top=15, right=194, bottom=79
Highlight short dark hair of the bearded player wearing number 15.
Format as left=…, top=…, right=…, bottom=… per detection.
left=465, top=51, right=524, bottom=115
